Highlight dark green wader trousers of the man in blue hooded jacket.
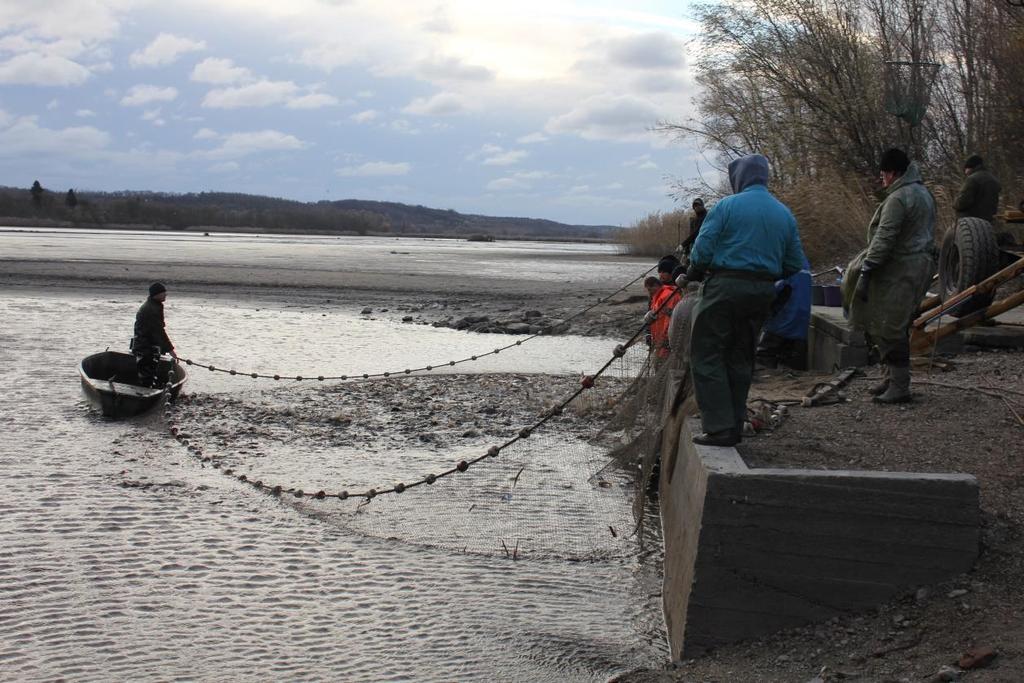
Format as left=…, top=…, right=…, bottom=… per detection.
left=690, top=273, right=775, bottom=434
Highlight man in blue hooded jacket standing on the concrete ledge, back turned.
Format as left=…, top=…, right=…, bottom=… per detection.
left=686, top=155, right=805, bottom=446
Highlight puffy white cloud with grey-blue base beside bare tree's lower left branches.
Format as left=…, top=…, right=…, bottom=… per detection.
left=544, top=94, right=658, bottom=141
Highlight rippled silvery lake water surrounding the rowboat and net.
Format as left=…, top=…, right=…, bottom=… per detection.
left=0, top=234, right=665, bottom=681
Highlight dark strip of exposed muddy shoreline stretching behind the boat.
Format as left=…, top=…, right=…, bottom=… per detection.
left=0, top=259, right=649, bottom=339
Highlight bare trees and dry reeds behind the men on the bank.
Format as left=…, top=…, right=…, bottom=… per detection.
left=659, top=0, right=1024, bottom=260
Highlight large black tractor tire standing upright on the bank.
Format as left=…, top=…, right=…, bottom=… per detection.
left=939, top=218, right=999, bottom=317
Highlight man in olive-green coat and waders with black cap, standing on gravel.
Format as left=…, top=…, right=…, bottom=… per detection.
left=844, top=148, right=936, bottom=403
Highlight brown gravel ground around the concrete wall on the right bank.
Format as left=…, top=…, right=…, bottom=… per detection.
left=625, top=351, right=1024, bottom=682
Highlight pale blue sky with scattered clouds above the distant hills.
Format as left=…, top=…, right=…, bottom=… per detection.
left=0, top=0, right=700, bottom=225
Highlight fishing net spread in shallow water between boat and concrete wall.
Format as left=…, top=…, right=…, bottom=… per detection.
left=165, top=344, right=668, bottom=560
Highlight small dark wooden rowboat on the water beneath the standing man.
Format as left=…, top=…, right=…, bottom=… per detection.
left=78, top=351, right=188, bottom=418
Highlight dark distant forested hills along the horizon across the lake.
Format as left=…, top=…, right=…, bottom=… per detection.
left=0, top=180, right=617, bottom=241
